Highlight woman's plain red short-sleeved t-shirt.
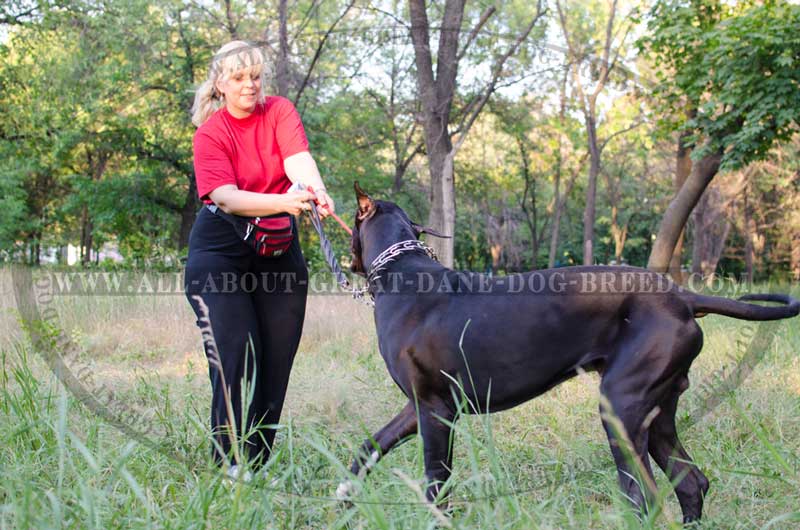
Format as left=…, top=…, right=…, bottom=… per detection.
left=192, top=96, right=308, bottom=204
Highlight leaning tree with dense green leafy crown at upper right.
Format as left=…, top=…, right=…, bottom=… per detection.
left=643, top=0, right=800, bottom=272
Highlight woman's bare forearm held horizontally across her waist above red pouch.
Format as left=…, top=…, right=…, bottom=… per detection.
left=208, top=184, right=321, bottom=217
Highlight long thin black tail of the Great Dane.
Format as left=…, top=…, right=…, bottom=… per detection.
left=687, top=293, right=800, bottom=320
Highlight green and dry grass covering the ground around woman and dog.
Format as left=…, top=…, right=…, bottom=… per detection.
left=0, top=275, right=800, bottom=529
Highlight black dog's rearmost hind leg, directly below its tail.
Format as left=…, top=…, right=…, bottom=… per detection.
left=649, top=374, right=708, bottom=523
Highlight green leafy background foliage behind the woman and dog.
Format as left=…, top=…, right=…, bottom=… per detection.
left=0, top=0, right=800, bottom=272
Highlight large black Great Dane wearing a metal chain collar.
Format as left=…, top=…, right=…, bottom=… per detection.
left=337, top=183, right=800, bottom=522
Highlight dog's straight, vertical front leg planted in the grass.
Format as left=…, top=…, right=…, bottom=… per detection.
left=419, top=398, right=456, bottom=508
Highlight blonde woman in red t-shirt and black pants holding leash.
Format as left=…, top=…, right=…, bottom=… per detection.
left=185, top=41, right=334, bottom=477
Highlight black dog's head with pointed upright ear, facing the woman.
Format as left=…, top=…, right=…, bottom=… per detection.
left=350, top=182, right=449, bottom=276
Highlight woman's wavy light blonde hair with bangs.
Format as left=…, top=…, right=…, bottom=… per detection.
left=192, top=40, right=269, bottom=127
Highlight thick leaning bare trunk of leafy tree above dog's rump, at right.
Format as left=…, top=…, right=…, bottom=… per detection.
left=647, top=148, right=722, bottom=272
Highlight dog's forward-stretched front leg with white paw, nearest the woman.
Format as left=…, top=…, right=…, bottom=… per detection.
left=336, top=401, right=417, bottom=500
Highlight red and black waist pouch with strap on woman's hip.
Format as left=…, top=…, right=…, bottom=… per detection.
left=206, top=204, right=294, bottom=258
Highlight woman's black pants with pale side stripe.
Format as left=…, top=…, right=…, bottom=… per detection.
left=185, top=204, right=308, bottom=464
